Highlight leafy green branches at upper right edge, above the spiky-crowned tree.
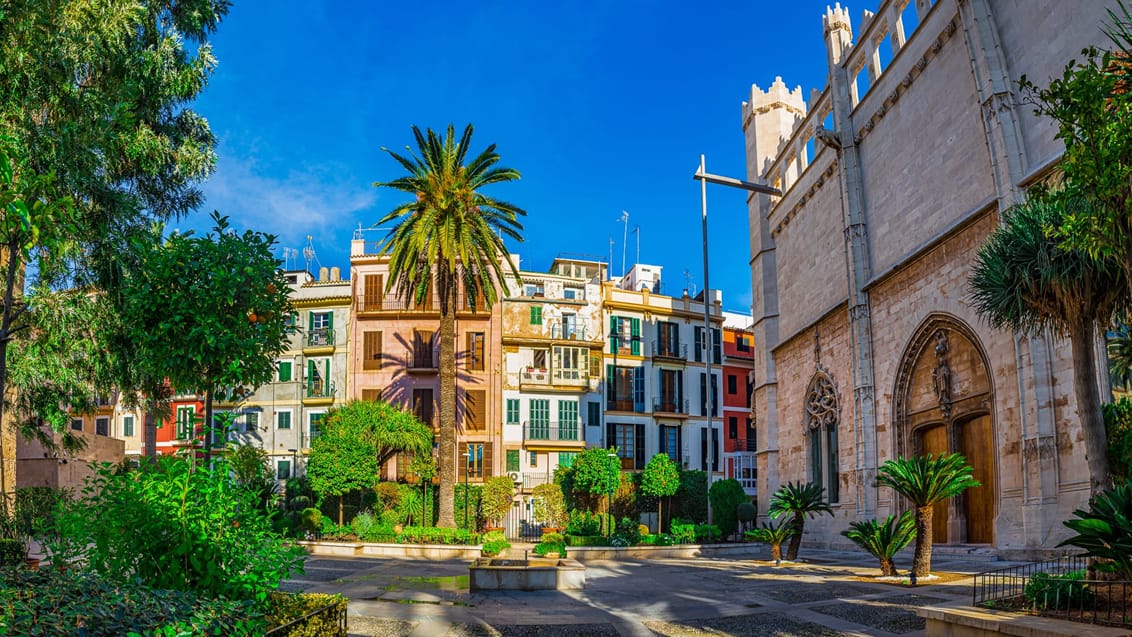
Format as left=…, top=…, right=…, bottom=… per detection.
left=1020, top=2, right=1132, bottom=300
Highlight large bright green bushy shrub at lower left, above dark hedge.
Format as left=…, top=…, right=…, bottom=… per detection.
left=48, top=457, right=303, bottom=600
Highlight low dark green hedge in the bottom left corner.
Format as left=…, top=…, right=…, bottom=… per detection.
left=0, top=568, right=267, bottom=637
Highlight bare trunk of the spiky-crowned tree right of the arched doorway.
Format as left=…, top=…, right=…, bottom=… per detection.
left=1069, top=320, right=1109, bottom=496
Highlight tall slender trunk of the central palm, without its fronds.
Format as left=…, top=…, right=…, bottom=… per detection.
left=436, top=285, right=457, bottom=528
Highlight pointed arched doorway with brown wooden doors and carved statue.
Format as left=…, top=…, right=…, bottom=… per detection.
left=893, top=315, right=997, bottom=544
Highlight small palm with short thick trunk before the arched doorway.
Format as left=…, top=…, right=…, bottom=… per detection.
left=876, top=454, right=981, bottom=577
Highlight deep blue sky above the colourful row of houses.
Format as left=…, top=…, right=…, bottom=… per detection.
left=190, top=0, right=837, bottom=311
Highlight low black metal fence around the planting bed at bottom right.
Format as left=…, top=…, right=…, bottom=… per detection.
left=972, top=556, right=1132, bottom=627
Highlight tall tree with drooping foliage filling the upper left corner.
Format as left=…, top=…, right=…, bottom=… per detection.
left=0, top=0, right=229, bottom=491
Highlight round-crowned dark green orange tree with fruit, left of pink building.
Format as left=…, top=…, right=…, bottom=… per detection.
left=114, top=213, right=291, bottom=458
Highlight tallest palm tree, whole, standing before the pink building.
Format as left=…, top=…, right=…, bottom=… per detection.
left=374, top=124, right=526, bottom=527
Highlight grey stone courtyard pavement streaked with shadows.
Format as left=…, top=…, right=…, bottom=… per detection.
left=285, top=550, right=1009, bottom=637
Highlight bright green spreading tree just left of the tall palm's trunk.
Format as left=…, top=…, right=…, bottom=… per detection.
left=307, top=401, right=432, bottom=525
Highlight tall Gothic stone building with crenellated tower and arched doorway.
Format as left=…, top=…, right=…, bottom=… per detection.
left=743, top=0, right=1112, bottom=554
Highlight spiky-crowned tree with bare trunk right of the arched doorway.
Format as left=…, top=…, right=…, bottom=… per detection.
left=970, top=190, right=1126, bottom=494
